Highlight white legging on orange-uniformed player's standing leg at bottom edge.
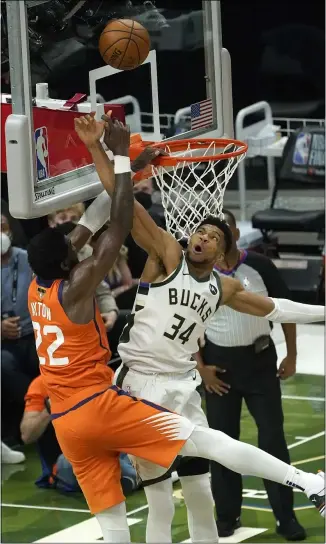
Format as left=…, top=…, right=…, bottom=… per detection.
left=95, top=502, right=130, bottom=544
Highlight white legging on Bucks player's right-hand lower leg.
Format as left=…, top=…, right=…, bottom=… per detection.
left=180, top=474, right=218, bottom=543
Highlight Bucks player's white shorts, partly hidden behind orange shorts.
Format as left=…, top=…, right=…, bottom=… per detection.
left=114, top=365, right=208, bottom=482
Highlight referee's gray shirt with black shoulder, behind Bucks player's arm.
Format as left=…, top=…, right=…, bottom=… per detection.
left=206, top=251, right=290, bottom=347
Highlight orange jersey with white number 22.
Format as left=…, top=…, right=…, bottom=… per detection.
left=28, top=278, right=113, bottom=410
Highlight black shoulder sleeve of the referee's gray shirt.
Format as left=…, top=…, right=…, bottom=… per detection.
left=245, top=251, right=291, bottom=298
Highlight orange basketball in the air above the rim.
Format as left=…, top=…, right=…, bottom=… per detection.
left=99, top=19, right=151, bottom=70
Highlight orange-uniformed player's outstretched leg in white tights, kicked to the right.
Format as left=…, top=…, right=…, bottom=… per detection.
left=109, top=384, right=325, bottom=516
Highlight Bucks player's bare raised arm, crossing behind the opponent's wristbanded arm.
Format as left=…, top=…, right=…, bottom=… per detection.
left=88, top=116, right=181, bottom=273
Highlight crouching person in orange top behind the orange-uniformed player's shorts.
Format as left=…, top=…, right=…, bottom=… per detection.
left=21, top=376, right=138, bottom=494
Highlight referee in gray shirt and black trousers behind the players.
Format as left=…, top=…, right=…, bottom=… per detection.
left=202, top=210, right=306, bottom=541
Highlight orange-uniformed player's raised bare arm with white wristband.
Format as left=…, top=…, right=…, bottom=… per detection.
left=69, top=118, right=134, bottom=299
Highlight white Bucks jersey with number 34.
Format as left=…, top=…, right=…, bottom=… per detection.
left=118, top=256, right=221, bottom=374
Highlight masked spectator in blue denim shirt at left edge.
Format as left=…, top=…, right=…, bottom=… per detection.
left=1, top=215, right=39, bottom=416
